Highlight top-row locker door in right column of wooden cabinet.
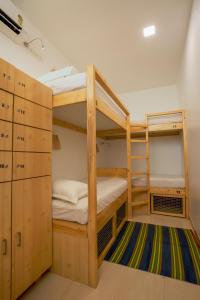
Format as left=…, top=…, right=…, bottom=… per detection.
left=15, top=69, right=52, bottom=109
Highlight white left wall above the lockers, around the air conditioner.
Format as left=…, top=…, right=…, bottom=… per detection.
left=0, top=0, right=70, bottom=78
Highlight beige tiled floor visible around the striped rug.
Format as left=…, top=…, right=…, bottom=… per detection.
left=21, top=215, right=200, bottom=300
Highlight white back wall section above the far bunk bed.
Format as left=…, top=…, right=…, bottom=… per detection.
left=120, top=85, right=181, bottom=122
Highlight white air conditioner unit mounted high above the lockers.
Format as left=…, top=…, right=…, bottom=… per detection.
left=0, top=1, right=23, bottom=43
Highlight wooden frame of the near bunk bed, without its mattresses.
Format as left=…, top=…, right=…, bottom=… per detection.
left=52, top=65, right=130, bottom=287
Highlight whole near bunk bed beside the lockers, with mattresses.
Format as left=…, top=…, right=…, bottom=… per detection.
left=52, top=65, right=130, bottom=287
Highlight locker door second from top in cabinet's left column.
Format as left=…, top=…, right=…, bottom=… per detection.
left=0, top=90, right=13, bottom=121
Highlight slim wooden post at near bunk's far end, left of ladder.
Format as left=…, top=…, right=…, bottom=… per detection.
left=126, top=116, right=133, bottom=219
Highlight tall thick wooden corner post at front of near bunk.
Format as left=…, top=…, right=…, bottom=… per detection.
left=87, top=65, right=98, bottom=287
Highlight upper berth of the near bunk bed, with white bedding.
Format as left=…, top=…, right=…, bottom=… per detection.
left=51, top=65, right=129, bottom=137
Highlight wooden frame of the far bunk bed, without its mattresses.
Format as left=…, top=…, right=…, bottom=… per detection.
left=131, top=110, right=189, bottom=218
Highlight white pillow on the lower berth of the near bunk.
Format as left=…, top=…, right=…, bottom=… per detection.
left=53, top=179, right=88, bottom=204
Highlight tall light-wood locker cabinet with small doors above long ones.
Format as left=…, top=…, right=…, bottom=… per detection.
left=0, top=59, right=52, bottom=300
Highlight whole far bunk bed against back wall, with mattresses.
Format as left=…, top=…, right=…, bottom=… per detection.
left=131, top=110, right=189, bottom=217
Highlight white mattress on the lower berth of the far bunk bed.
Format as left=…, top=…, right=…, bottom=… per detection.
left=132, top=175, right=185, bottom=188
